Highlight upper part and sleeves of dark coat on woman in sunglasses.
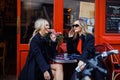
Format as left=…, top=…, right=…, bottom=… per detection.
left=67, top=34, right=95, bottom=61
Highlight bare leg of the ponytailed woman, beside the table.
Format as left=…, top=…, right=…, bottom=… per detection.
left=51, top=63, right=63, bottom=80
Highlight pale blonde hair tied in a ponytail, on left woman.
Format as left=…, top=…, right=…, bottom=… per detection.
left=29, top=18, right=48, bottom=42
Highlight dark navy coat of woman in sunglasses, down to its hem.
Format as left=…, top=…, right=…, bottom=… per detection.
left=67, top=34, right=105, bottom=80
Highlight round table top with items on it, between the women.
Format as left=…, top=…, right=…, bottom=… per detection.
left=52, top=54, right=77, bottom=63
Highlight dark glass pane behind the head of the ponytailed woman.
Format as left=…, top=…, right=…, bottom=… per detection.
left=21, top=0, right=53, bottom=44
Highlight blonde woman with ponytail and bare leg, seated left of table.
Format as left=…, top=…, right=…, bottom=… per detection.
left=19, top=19, right=63, bottom=80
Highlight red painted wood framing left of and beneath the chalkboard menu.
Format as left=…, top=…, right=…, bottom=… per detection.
left=95, top=0, right=120, bottom=49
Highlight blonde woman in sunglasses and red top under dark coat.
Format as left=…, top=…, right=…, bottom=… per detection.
left=67, top=20, right=104, bottom=80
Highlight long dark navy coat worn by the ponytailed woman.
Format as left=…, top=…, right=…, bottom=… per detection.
left=19, top=33, right=57, bottom=80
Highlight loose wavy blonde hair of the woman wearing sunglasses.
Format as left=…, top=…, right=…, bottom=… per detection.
left=74, top=19, right=92, bottom=39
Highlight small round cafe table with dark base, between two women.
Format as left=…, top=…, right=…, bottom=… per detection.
left=52, top=54, right=78, bottom=80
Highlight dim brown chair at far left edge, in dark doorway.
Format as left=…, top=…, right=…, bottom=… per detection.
left=0, top=41, right=6, bottom=76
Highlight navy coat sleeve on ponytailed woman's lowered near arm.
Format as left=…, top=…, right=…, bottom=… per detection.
left=30, top=39, right=50, bottom=72
